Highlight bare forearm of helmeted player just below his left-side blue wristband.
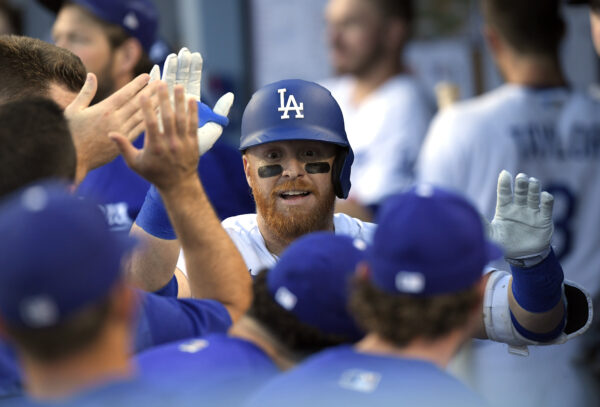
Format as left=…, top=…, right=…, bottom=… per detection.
left=126, top=223, right=180, bottom=292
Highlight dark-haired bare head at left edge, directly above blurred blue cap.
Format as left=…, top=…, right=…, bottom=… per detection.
left=0, top=98, right=77, bottom=196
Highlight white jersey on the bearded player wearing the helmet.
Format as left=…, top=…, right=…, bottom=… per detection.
left=177, top=213, right=376, bottom=275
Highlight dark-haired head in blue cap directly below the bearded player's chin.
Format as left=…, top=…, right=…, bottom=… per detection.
left=248, top=232, right=366, bottom=357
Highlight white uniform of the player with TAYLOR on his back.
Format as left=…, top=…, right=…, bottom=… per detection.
left=417, top=84, right=600, bottom=406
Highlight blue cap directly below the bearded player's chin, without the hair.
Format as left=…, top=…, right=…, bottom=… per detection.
left=267, top=232, right=367, bottom=340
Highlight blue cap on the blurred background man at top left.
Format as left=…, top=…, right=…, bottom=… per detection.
left=72, top=0, right=158, bottom=54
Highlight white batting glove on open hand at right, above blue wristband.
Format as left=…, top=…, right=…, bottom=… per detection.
left=488, top=170, right=554, bottom=267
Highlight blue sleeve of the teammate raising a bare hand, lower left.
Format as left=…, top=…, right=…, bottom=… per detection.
left=134, top=292, right=232, bottom=352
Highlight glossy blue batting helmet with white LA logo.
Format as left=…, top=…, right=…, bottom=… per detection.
left=240, top=79, right=354, bottom=198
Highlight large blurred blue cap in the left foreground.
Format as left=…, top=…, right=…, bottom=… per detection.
left=0, top=182, right=135, bottom=328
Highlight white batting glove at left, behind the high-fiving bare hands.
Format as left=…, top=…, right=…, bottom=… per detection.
left=150, top=48, right=234, bottom=155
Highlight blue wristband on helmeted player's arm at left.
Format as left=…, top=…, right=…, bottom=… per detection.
left=135, top=185, right=177, bottom=240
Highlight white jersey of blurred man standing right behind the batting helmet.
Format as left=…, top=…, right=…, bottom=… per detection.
left=322, top=75, right=433, bottom=205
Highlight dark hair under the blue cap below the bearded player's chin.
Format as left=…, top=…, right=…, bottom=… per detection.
left=247, top=270, right=351, bottom=355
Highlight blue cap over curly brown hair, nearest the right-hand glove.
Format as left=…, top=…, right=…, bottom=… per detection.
left=368, top=184, right=502, bottom=297
